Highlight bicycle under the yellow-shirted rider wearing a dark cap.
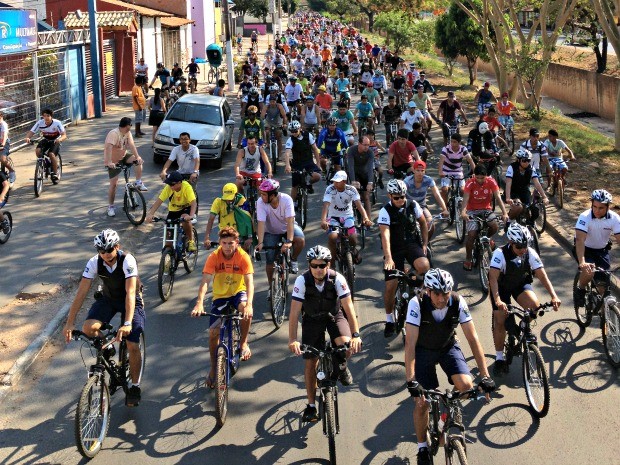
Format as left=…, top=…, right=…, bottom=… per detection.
left=153, top=217, right=198, bottom=302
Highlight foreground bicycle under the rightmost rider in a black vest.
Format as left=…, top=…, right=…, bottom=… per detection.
left=491, top=302, right=553, bottom=418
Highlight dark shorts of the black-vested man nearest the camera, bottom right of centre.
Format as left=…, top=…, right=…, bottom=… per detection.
left=415, top=342, right=470, bottom=389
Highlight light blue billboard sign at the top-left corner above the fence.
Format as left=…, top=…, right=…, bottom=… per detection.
left=0, top=8, right=37, bottom=55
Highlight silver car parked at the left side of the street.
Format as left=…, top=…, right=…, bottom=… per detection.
left=153, top=94, right=235, bottom=168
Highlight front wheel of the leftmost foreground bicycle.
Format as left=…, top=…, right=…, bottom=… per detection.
left=75, top=374, right=110, bottom=459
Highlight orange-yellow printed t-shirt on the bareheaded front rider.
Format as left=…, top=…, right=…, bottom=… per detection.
left=202, top=247, right=254, bottom=300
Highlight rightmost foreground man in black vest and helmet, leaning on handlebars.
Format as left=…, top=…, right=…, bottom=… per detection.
left=489, top=223, right=562, bottom=376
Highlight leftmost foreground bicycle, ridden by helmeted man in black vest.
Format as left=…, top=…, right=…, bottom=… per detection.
left=71, top=323, right=146, bottom=459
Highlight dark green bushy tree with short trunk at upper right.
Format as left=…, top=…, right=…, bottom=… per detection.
left=435, top=4, right=489, bottom=85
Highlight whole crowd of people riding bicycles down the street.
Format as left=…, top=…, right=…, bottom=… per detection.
left=0, top=10, right=620, bottom=464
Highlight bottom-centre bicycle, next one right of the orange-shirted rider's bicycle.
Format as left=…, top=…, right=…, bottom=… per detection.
left=301, top=340, right=349, bottom=465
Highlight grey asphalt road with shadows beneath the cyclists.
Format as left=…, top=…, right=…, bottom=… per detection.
left=0, top=88, right=620, bottom=465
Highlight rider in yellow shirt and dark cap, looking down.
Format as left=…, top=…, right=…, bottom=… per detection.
left=144, top=171, right=198, bottom=253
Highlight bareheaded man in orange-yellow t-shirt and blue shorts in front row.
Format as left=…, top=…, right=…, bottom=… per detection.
left=191, top=226, right=254, bottom=389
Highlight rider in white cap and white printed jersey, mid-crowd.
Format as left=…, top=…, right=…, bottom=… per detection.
left=321, top=171, right=372, bottom=264
